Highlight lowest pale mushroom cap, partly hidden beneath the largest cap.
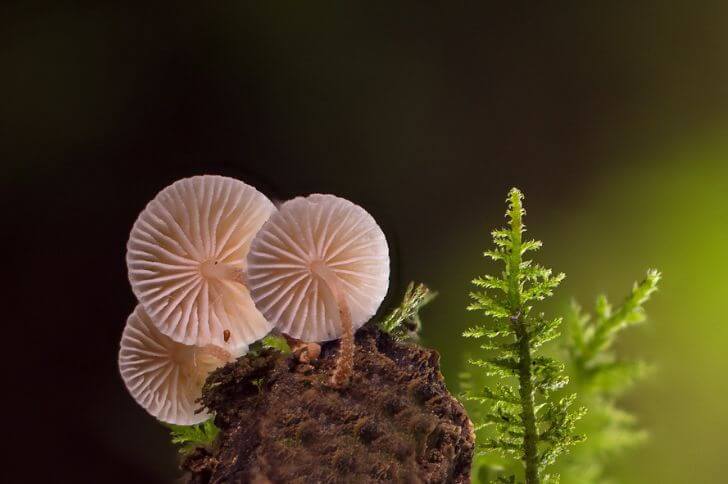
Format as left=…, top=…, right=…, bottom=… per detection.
left=119, top=304, right=229, bottom=425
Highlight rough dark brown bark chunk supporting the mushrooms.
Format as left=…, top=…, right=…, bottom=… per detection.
left=183, top=326, right=474, bottom=483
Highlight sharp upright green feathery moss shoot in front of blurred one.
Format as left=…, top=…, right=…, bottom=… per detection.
left=463, top=188, right=584, bottom=484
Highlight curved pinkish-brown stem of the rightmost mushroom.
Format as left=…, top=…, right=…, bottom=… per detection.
left=311, top=261, right=354, bottom=387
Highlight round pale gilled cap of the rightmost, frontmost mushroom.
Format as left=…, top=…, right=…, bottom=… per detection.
left=247, top=194, right=389, bottom=341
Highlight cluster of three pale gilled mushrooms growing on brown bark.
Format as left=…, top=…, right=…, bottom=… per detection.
left=119, top=175, right=389, bottom=425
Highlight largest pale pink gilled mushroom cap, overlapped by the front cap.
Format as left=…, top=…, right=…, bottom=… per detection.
left=126, top=175, right=275, bottom=355
